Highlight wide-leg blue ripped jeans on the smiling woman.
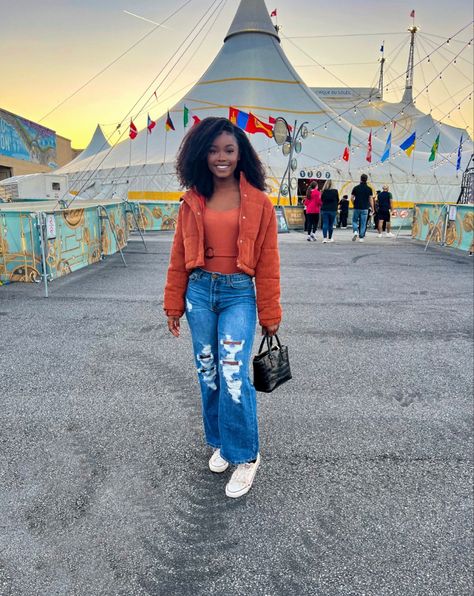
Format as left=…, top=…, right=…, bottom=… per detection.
left=186, top=269, right=258, bottom=464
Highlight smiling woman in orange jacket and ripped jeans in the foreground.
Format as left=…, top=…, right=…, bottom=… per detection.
left=164, top=118, right=281, bottom=497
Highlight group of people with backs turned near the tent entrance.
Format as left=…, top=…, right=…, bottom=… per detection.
left=304, top=174, right=393, bottom=244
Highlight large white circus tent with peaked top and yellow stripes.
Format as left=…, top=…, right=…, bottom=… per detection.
left=55, top=0, right=472, bottom=202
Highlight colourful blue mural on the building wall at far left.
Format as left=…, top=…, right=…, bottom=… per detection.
left=0, top=109, right=57, bottom=168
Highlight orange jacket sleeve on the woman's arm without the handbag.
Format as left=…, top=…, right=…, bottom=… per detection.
left=163, top=205, right=189, bottom=317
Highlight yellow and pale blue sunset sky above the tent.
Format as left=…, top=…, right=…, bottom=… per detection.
left=0, top=0, right=474, bottom=148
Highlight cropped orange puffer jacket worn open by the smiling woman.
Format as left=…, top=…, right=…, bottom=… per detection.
left=163, top=174, right=281, bottom=327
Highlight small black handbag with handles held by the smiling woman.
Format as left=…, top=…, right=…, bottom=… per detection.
left=253, top=335, right=291, bottom=393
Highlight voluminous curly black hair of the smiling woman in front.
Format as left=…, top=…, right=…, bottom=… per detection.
left=176, top=117, right=265, bottom=199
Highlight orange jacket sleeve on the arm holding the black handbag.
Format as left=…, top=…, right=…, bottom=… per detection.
left=255, top=206, right=282, bottom=327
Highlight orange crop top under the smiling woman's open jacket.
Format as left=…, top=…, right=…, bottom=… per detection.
left=203, top=207, right=241, bottom=274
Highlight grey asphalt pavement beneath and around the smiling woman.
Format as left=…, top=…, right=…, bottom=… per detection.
left=0, top=230, right=474, bottom=596
